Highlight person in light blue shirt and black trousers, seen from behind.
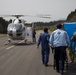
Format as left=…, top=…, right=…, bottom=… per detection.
left=49, top=24, right=70, bottom=73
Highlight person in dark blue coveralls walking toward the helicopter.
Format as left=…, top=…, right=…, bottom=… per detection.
left=37, top=28, right=50, bottom=66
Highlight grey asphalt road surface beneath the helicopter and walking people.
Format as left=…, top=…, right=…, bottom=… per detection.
left=0, top=30, right=76, bottom=75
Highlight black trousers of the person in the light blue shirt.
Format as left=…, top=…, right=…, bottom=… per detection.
left=54, top=46, right=66, bottom=72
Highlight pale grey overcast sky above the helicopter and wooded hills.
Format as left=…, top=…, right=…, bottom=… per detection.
left=0, top=0, right=76, bottom=22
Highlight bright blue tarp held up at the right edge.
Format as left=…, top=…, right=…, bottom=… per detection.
left=64, top=22, right=76, bottom=52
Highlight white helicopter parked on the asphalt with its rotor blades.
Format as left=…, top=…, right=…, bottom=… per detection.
left=5, top=15, right=50, bottom=45
